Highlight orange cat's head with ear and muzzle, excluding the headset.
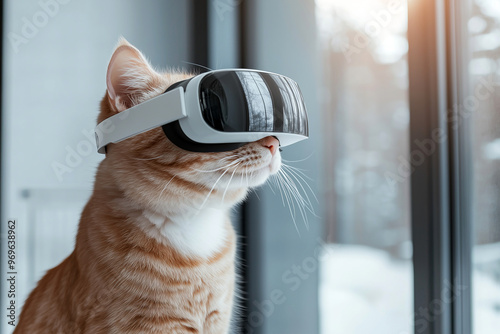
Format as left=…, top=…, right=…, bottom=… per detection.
left=98, top=39, right=281, bottom=213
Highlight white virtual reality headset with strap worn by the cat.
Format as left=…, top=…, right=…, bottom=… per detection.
left=95, top=69, right=309, bottom=153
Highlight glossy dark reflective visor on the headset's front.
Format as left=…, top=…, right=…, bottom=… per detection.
left=200, top=71, right=309, bottom=136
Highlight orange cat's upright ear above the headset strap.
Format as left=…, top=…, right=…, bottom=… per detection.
left=106, top=37, right=158, bottom=112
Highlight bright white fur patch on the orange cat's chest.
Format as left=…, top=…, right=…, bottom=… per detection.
left=144, top=208, right=229, bottom=258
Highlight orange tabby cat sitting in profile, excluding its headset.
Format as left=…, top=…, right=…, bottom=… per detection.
left=14, top=40, right=281, bottom=334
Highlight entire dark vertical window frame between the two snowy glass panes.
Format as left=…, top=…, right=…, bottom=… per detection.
left=408, top=0, right=472, bottom=334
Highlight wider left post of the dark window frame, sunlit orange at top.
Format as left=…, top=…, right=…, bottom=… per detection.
left=408, top=0, right=452, bottom=334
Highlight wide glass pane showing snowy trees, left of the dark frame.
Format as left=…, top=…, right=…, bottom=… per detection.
left=316, top=0, right=413, bottom=334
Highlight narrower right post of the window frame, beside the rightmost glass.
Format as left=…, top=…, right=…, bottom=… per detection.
left=446, top=0, right=473, bottom=334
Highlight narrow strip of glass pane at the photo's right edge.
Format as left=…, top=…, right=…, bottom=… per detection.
left=470, top=0, right=500, bottom=334
